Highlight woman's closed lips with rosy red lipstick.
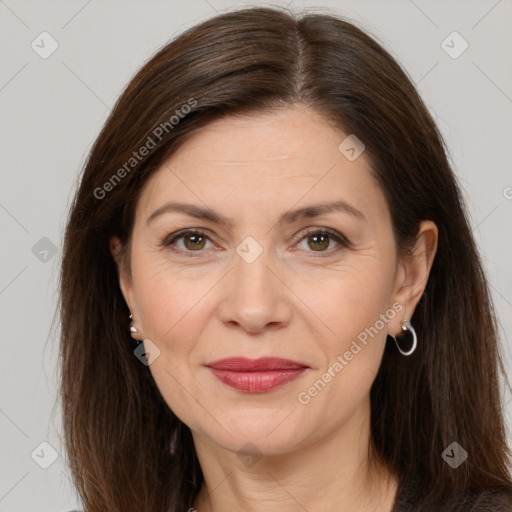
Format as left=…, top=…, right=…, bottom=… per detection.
left=206, top=357, right=309, bottom=393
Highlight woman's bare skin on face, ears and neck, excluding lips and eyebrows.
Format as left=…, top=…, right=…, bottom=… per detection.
left=111, top=106, right=437, bottom=512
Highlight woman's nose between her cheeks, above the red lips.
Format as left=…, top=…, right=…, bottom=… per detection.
left=219, top=250, right=292, bottom=334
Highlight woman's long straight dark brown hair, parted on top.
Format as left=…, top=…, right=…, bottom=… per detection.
left=60, top=8, right=512, bottom=512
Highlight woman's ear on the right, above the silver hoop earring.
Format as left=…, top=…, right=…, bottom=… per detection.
left=389, top=220, right=438, bottom=336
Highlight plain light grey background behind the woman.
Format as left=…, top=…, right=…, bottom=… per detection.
left=0, top=0, right=512, bottom=512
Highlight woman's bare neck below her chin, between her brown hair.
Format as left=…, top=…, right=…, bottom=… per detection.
left=193, top=400, right=398, bottom=512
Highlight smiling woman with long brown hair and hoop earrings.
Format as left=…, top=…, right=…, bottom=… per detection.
left=61, top=8, right=512, bottom=512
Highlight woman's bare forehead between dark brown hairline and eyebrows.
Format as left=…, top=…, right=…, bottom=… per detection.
left=134, top=106, right=387, bottom=228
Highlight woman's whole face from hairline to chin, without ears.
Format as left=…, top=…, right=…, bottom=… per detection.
left=113, top=107, right=411, bottom=454
